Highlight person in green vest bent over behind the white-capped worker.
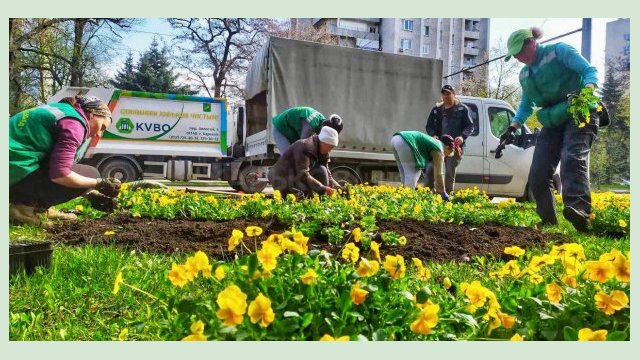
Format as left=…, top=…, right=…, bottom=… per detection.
left=272, top=106, right=343, bottom=154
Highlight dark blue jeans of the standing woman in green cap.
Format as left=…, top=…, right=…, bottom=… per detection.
left=529, top=111, right=600, bottom=224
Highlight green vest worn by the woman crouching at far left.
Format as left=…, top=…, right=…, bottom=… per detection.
left=9, top=103, right=90, bottom=186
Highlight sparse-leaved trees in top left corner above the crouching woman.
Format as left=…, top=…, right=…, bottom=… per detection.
left=9, top=18, right=136, bottom=113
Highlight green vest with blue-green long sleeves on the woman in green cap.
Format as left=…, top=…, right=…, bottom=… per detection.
left=514, top=43, right=598, bottom=127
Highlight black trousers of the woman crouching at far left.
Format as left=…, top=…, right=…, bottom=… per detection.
left=9, top=164, right=100, bottom=209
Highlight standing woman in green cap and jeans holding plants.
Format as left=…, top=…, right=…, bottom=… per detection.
left=501, top=28, right=600, bottom=232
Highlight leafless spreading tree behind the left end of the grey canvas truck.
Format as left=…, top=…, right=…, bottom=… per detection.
left=169, top=18, right=267, bottom=97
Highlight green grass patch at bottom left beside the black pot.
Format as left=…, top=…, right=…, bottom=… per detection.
left=9, top=246, right=179, bottom=340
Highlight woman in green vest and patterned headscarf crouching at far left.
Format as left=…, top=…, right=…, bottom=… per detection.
left=9, top=96, right=120, bottom=226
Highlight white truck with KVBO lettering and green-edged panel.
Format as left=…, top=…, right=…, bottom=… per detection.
left=49, top=87, right=238, bottom=181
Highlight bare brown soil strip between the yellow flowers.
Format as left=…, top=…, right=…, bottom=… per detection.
left=48, top=214, right=566, bottom=261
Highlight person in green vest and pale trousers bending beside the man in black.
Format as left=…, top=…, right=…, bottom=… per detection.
left=391, top=131, right=455, bottom=200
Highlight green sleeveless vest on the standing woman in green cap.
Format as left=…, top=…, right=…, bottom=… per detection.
left=520, top=44, right=582, bottom=127
